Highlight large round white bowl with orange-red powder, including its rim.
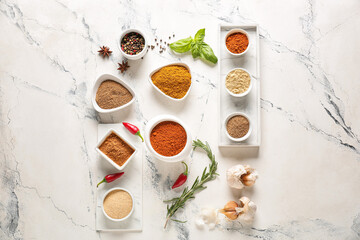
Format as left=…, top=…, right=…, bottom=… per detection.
left=145, top=115, right=192, bottom=162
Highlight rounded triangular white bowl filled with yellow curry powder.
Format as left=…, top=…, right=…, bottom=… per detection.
left=149, top=63, right=191, bottom=101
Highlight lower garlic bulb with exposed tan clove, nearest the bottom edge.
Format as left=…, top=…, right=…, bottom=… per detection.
left=219, top=197, right=256, bottom=224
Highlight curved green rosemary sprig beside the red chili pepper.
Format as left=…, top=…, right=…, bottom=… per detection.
left=164, top=140, right=219, bottom=228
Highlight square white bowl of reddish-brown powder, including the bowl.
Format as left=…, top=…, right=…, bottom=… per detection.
left=96, top=129, right=137, bottom=171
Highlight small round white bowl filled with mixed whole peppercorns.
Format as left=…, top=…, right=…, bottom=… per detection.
left=119, top=28, right=147, bottom=60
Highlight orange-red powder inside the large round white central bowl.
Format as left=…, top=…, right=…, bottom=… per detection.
left=150, top=121, right=187, bottom=157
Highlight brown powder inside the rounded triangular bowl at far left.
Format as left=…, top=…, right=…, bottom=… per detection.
left=96, top=80, right=133, bottom=109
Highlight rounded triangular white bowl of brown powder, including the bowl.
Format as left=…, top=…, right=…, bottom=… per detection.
left=92, top=74, right=135, bottom=113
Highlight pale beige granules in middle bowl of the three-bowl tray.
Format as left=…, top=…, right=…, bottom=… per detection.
left=225, top=69, right=251, bottom=94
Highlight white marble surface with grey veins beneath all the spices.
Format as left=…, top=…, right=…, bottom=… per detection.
left=0, top=0, right=360, bottom=240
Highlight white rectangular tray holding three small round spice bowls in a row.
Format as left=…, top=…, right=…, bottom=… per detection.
left=218, top=24, right=261, bottom=147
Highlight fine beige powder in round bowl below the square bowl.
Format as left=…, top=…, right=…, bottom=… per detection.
left=103, top=190, right=133, bottom=219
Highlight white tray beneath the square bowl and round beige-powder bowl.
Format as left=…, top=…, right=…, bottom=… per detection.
left=95, top=123, right=143, bottom=232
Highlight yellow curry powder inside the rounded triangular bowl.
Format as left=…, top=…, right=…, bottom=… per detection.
left=151, top=65, right=191, bottom=99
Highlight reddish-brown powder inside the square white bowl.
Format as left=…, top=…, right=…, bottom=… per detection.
left=99, top=133, right=135, bottom=167
